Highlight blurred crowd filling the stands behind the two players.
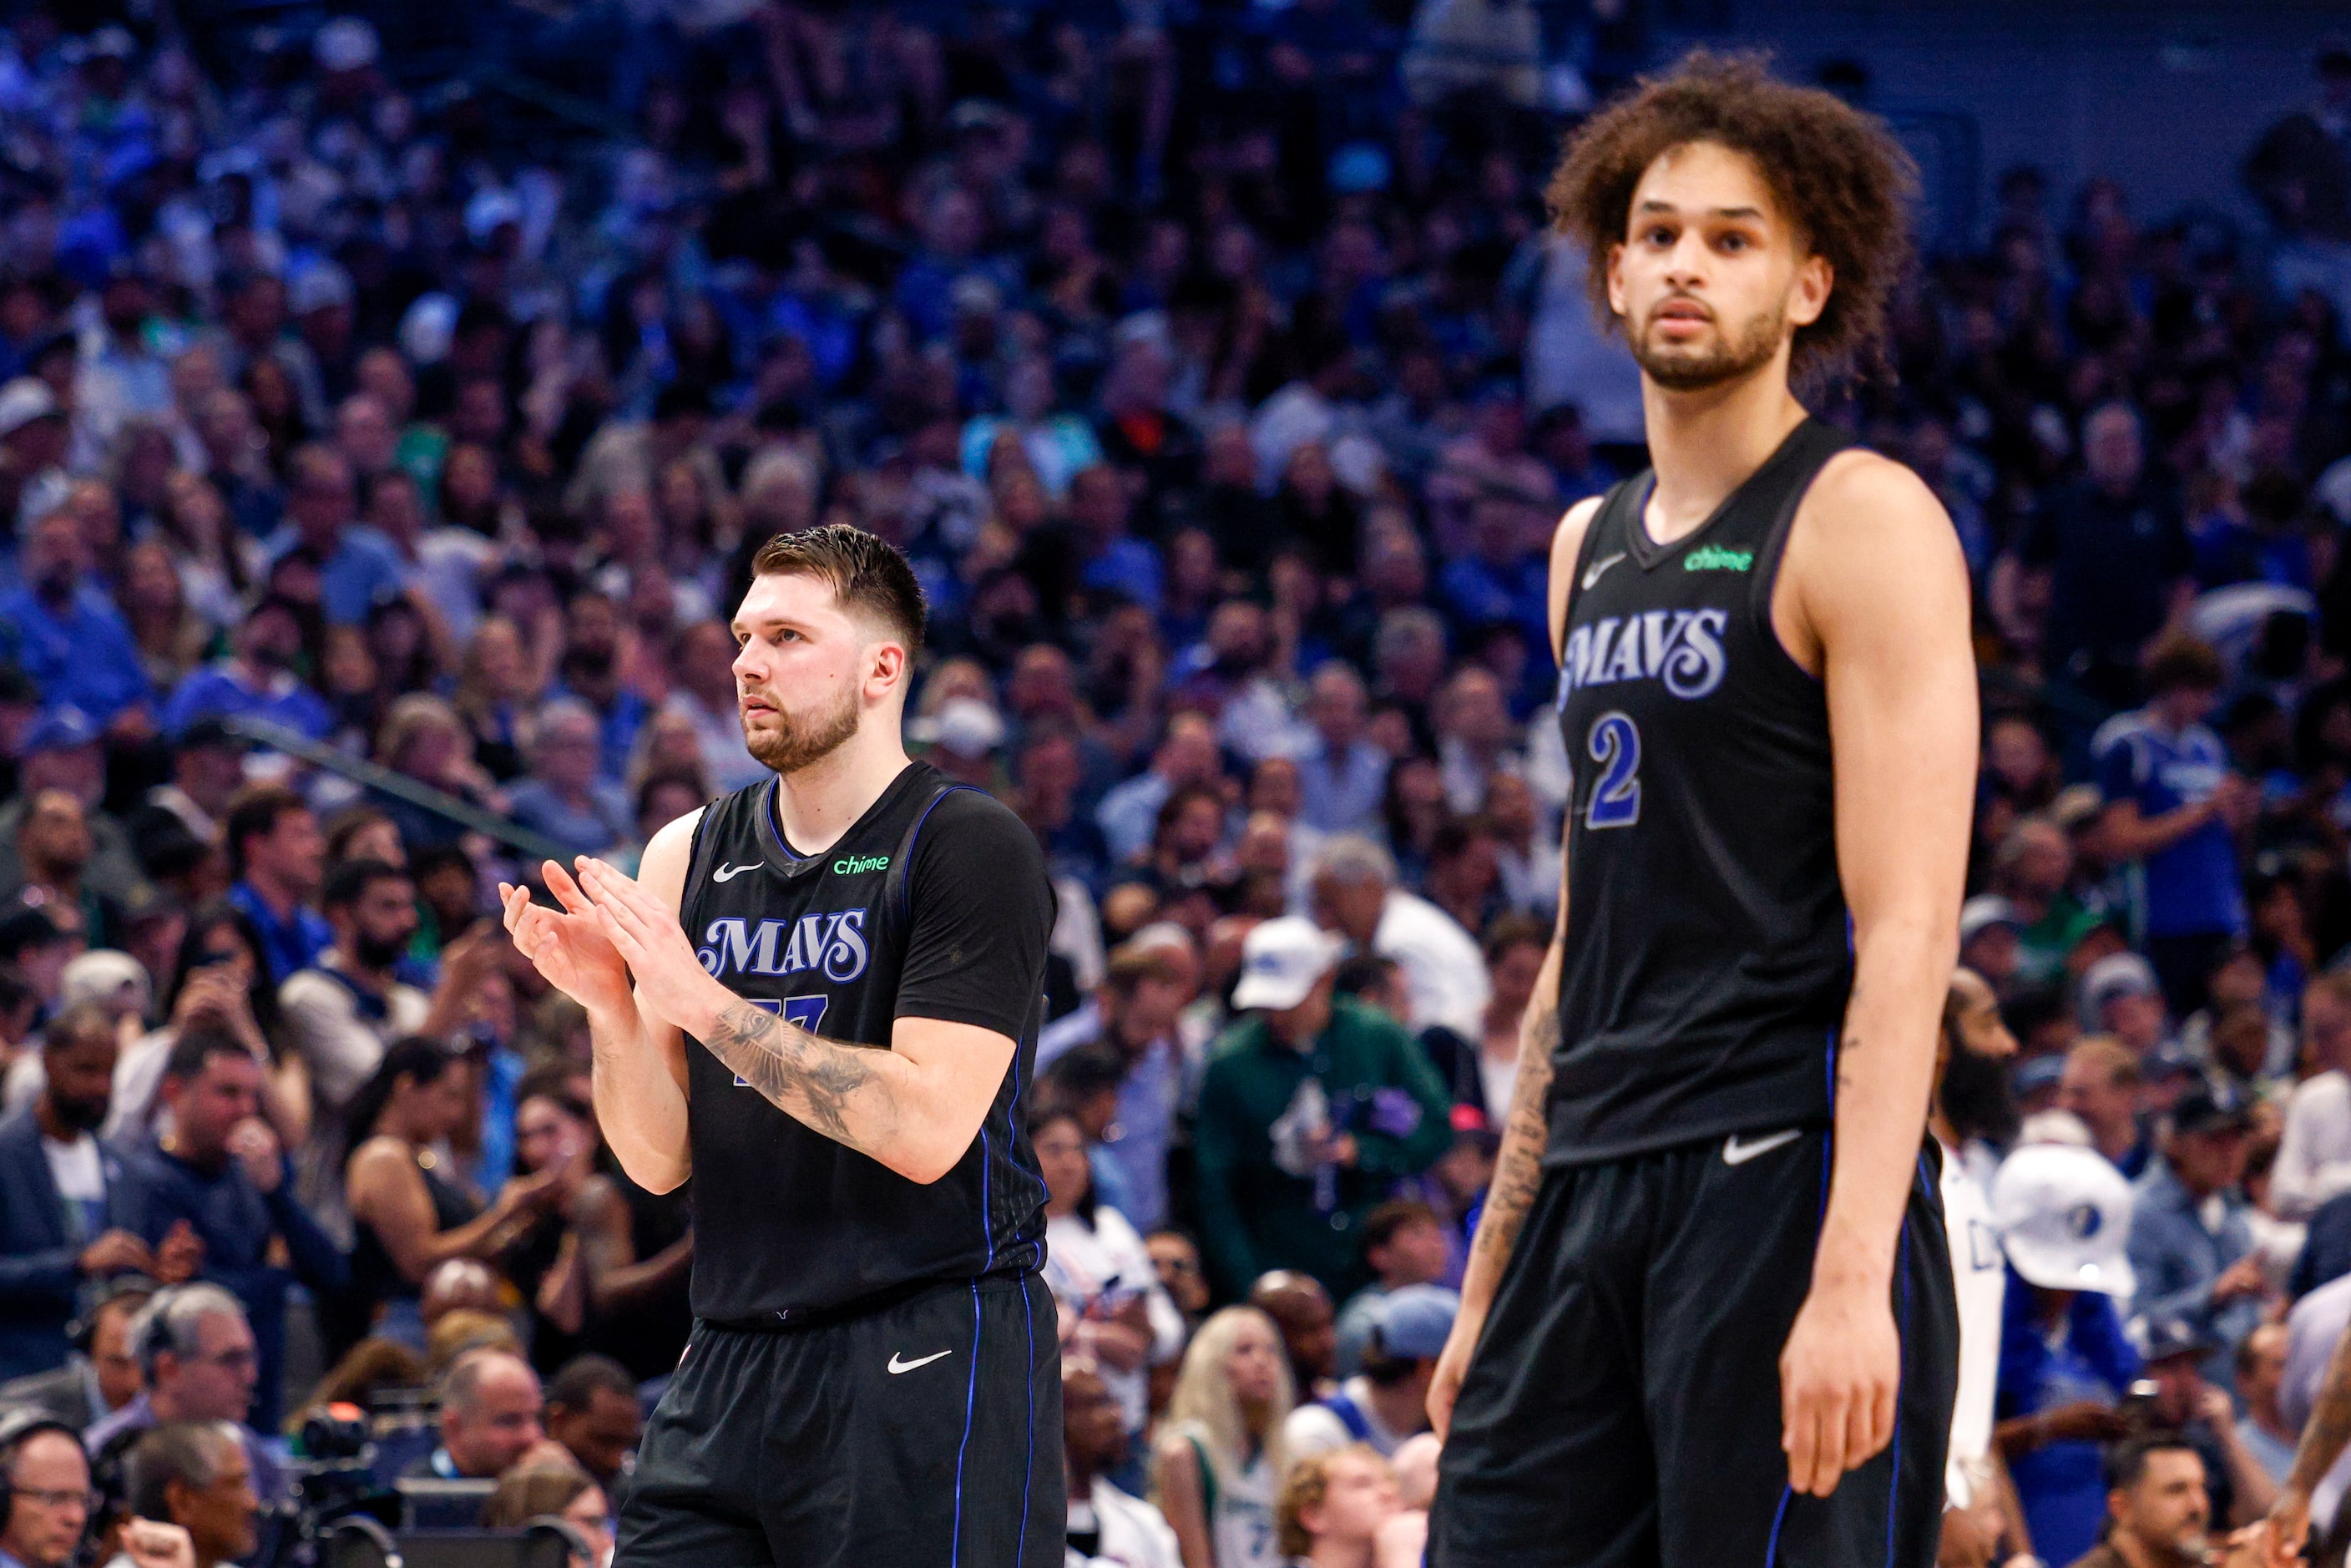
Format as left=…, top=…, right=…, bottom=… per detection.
left=0, top=0, right=2351, bottom=1568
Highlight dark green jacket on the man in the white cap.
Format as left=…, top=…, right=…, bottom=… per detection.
left=1195, top=999, right=1453, bottom=1300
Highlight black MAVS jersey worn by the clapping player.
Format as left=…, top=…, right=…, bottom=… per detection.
left=680, top=761, right=1054, bottom=1326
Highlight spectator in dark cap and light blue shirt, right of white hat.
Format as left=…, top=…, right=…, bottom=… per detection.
left=2130, top=1084, right=2268, bottom=1383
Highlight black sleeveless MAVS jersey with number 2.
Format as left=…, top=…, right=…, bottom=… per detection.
left=1547, top=421, right=1853, bottom=1164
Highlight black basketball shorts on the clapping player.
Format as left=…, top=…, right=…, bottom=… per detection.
left=614, top=1274, right=1067, bottom=1568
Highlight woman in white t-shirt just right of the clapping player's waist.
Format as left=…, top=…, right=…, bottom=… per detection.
left=1029, top=1105, right=1185, bottom=1436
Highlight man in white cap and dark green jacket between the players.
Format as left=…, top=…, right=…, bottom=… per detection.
left=1195, top=921, right=1453, bottom=1297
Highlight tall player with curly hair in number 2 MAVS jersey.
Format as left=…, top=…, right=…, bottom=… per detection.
left=1429, top=57, right=1977, bottom=1568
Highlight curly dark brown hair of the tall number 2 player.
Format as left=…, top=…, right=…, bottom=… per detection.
left=1545, top=49, right=1919, bottom=386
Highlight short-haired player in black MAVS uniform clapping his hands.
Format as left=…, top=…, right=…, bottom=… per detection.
left=498, top=527, right=1067, bottom=1568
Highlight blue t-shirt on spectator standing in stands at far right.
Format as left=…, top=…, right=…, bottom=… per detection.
left=2090, top=710, right=2245, bottom=936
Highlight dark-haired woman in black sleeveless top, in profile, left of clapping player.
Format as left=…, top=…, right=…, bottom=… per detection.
left=331, top=1037, right=562, bottom=1353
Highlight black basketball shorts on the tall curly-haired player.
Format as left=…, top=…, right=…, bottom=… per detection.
left=1429, top=1130, right=1959, bottom=1568
